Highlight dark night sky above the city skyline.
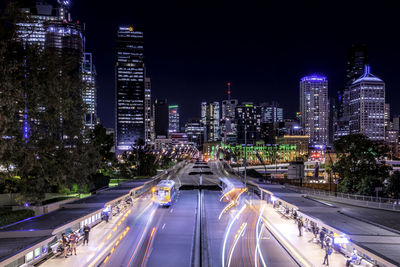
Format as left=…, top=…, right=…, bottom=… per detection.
left=71, top=0, right=400, bottom=127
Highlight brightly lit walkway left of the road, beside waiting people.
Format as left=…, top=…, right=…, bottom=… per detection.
left=40, top=210, right=123, bottom=267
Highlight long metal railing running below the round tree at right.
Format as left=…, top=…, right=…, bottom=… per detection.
left=285, top=185, right=400, bottom=211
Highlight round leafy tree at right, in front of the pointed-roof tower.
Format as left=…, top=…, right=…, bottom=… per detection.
left=334, top=134, right=390, bottom=195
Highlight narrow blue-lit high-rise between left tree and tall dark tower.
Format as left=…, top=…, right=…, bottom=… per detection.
left=82, top=53, right=97, bottom=129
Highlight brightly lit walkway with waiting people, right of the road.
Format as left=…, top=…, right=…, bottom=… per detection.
left=263, top=204, right=346, bottom=267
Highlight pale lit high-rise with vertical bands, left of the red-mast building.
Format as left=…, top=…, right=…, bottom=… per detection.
left=201, top=102, right=220, bottom=142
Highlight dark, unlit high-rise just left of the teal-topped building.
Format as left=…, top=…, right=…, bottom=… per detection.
left=153, top=99, right=169, bottom=138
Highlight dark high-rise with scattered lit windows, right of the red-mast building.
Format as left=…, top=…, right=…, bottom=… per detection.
left=235, top=102, right=261, bottom=144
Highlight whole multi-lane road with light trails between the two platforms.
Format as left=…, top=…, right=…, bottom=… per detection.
left=44, top=162, right=296, bottom=267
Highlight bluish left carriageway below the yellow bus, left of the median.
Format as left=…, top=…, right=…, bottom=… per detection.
left=102, top=190, right=198, bottom=267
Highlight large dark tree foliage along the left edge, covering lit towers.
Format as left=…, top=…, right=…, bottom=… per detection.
left=0, top=1, right=101, bottom=201
